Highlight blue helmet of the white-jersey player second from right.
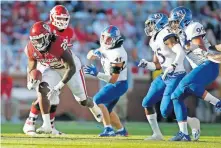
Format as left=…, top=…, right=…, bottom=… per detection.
left=144, top=13, right=168, bottom=36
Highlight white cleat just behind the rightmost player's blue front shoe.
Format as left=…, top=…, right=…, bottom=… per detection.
left=187, top=118, right=200, bottom=141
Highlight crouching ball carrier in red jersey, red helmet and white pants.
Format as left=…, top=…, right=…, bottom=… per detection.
left=23, top=22, right=102, bottom=135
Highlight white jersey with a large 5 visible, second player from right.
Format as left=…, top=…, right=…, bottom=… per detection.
left=149, top=27, right=185, bottom=72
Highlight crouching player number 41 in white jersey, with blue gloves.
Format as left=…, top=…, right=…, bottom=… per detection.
left=84, top=25, right=128, bottom=137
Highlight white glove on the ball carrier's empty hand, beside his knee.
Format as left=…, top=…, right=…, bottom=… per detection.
left=47, top=81, right=65, bottom=102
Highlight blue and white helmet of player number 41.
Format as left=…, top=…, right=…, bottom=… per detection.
left=100, top=25, right=122, bottom=49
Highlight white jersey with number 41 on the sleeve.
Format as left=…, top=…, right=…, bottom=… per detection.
left=100, top=46, right=127, bottom=81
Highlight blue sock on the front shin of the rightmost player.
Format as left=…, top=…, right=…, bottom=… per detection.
left=173, top=99, right=187, bottom=122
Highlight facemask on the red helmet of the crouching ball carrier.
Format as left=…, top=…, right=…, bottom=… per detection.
left=30, top=33, right=50, bottom=52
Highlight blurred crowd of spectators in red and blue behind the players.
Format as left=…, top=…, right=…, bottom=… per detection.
left=1, top=0, right=221, bottom=122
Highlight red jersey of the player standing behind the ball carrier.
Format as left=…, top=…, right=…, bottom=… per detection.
left=48, top=23, right=74, bottom=44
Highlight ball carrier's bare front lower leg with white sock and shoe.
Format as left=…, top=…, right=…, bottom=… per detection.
left=36, top=82, right=52, bottom=134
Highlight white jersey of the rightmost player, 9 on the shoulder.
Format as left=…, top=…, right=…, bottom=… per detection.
left=184, top=22, right=211, bottom=68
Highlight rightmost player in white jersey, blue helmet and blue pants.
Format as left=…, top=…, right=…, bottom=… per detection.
left=167, top=7, right=221, bottom=141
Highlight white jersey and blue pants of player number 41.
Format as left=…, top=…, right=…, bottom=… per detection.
left=93, top=46, right=128, bottom=113
